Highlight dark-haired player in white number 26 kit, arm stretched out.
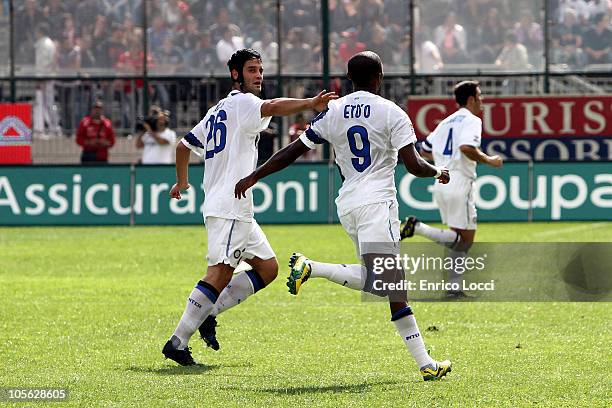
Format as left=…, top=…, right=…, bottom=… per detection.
left=162, top=49, right=337, bottom=365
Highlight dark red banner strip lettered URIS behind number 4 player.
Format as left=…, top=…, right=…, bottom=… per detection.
left=407, top=96, right=612, bottom=140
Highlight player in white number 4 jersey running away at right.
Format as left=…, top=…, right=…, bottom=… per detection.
left=402, top=81, right=503, bottom=297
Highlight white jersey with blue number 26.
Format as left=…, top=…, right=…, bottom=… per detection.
left=182, top=90, right=272, bottom=222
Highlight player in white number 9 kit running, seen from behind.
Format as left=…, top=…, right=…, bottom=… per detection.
left=235, top=51, right=451, bottom=380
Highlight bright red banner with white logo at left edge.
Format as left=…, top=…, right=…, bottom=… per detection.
left=0, top=103, right=32, bottom=164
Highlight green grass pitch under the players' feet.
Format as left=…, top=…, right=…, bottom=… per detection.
left=0, top=222, right=612, bottom=407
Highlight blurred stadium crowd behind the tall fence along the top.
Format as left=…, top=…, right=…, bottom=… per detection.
left=10, top=0, right=612, bottom=74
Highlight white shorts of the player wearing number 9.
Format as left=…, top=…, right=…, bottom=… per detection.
left=340, top=201, right=400, bottom=257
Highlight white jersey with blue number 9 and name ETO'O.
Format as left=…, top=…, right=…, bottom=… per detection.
left=300, top=91, right=416, bottom=216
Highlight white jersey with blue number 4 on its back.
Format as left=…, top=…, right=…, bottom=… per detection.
left=421, top=108, right=482, bottom=179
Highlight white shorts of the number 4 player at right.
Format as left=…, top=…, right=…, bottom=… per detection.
left=433, top=175, right=477, bottom=230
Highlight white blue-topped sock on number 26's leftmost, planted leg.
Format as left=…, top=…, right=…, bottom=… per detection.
left=174, top=283, right=217, bottom=350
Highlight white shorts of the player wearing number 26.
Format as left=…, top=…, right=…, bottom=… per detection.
left=204, top=217, right=276, bottom=268
